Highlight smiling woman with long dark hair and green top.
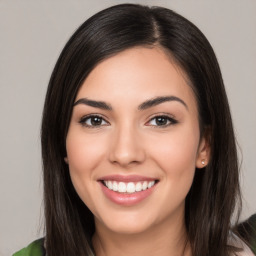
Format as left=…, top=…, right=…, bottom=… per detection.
left=12, top=4, right=252, bottom=256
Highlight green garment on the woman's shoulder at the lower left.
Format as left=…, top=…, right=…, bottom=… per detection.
left=13, top=238, right=45, bottom=256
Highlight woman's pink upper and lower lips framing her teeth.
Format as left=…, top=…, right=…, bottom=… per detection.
left=99, top=175, right=157, bottom=206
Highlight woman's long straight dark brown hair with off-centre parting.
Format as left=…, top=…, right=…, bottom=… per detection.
left=41, top=4, right=241, bottom=256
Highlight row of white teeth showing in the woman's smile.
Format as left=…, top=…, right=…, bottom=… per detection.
left=104, top=180, right=155, bottom=193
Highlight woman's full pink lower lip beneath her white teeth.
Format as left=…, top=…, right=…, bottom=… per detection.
left=99, top=182, right=156, bottom=206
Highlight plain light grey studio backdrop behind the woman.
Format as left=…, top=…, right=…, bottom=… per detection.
left=0, top=0, right=256, bottom=256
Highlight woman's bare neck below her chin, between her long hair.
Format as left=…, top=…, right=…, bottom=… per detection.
left=93, top=212, right=191, bottom=256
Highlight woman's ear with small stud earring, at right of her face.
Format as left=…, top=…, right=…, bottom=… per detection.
left=196, top=133, right=211, bottom=169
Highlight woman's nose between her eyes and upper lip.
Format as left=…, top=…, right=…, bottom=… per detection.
left=109, top=124, right=146, bottom=168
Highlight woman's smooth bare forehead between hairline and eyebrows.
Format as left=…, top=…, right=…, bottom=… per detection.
left=77, top=47, right=195, bottom=111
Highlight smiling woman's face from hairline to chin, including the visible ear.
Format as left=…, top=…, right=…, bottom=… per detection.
left=66, top=47, right=207, bottom=234
